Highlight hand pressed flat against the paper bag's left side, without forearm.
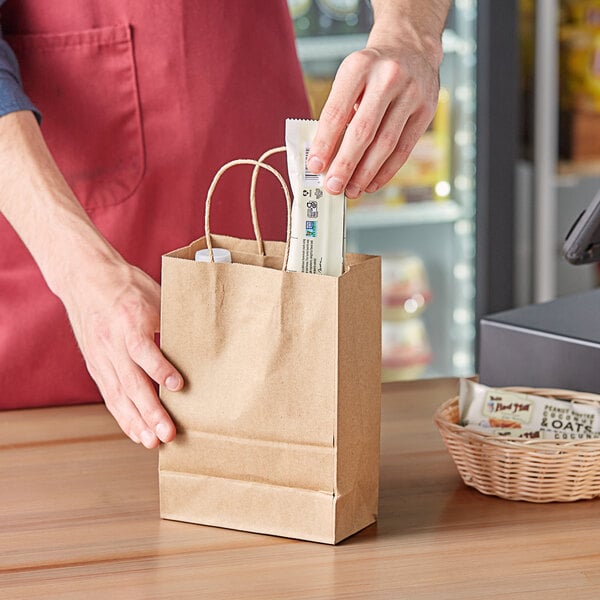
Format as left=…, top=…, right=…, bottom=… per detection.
left=62, top=261, right=183, bottom=448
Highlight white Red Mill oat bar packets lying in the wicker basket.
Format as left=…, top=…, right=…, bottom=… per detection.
left=458, top=379, right=600, bottom=441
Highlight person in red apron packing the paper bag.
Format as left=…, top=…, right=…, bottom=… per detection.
left=0, top=0, right=449, bottom=448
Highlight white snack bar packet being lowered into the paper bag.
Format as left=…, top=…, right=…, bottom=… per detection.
left=285, top=119, right=346, bottom=277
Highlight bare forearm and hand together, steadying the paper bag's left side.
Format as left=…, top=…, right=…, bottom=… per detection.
left=0, top=111, right=183, bottom=448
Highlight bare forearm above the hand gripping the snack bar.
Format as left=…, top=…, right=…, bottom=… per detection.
left=368, top=0, right=451, bottom=68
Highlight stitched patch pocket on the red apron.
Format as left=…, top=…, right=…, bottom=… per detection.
left=6, top=25, right=144, bottom=211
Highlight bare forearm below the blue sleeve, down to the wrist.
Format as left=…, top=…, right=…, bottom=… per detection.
left=0, top=111, right=121, bottom=297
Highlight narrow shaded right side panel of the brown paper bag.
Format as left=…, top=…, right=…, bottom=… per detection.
left=335, top=254, right=381, bottom=542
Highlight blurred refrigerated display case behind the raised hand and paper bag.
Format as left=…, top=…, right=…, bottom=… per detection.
left=289, top=0, right=516, bottom=379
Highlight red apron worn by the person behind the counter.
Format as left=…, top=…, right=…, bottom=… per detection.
left=0, top=0, right=309, bottom=408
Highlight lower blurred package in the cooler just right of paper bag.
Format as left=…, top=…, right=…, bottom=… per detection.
left=381, top=317, right=432, bottom=381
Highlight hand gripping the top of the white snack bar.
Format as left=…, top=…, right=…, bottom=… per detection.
left=307, top=6, right=443, bottom=198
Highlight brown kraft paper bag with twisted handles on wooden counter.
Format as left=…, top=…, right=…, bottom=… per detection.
left=159, top=121, right=381, bottom=544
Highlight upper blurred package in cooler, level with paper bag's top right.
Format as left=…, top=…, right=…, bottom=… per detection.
left=381, top=254, right=431, bottom=320
